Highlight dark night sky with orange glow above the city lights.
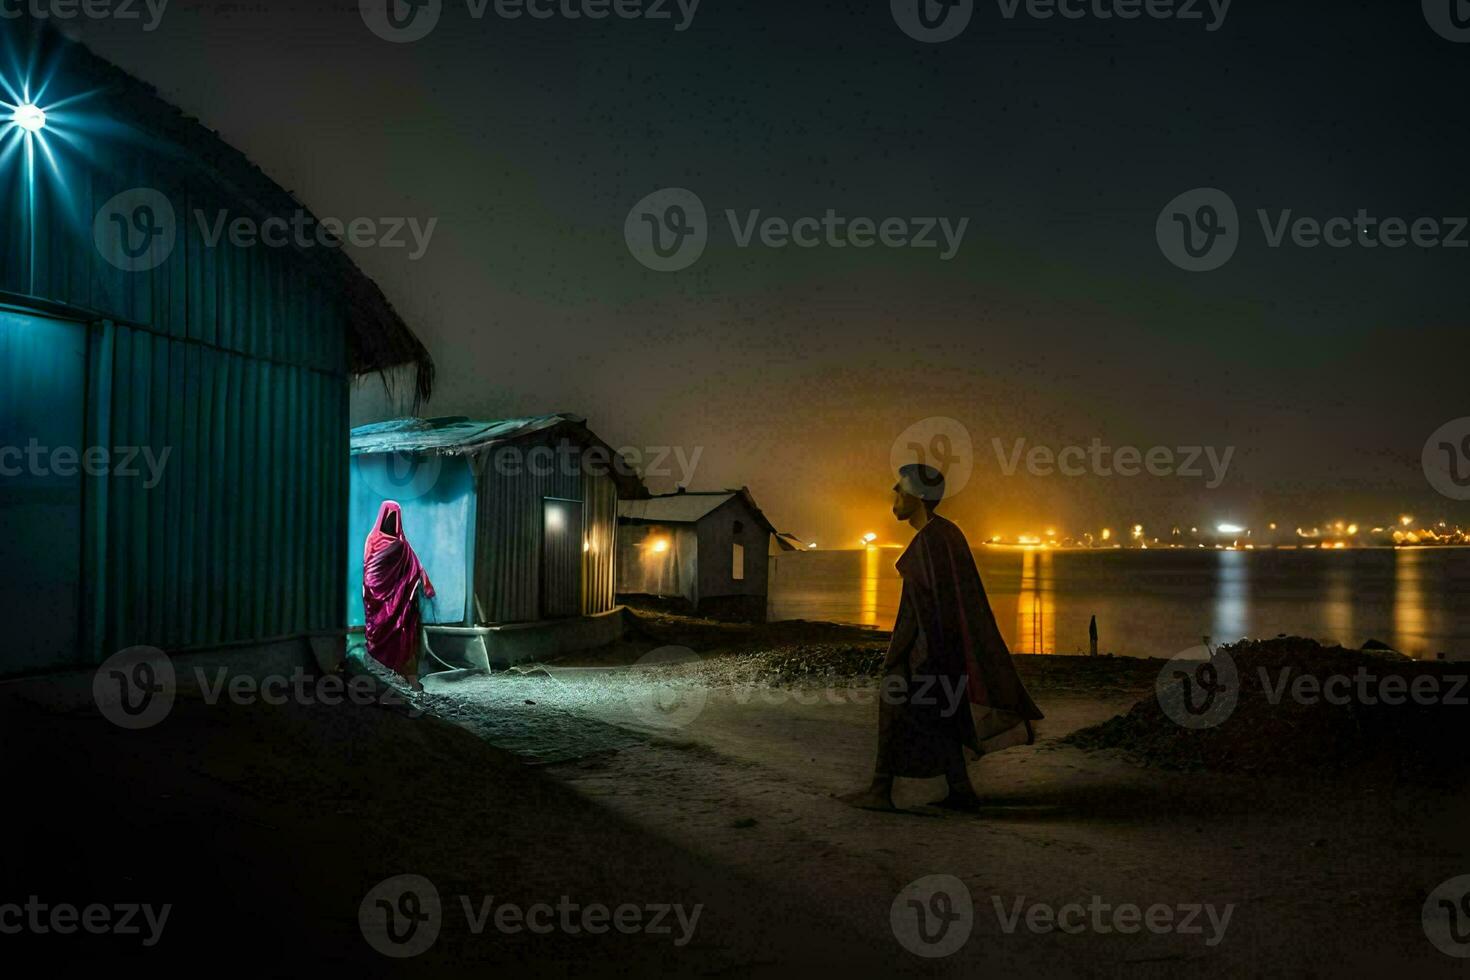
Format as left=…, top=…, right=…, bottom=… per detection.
left=54, top=0, right=1470, bottom=547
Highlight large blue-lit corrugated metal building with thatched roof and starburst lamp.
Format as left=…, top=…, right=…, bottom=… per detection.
left=0, top=18, right=432, bottom=674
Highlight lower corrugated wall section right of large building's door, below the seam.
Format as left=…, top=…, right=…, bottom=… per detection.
left=84, top=323, right=347, bottom=652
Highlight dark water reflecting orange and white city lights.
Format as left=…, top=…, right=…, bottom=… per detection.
left=770, top=548, right=1470, bottom=660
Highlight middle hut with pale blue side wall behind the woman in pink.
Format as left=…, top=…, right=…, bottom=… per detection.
left=347, top=414, right=647, bottom=669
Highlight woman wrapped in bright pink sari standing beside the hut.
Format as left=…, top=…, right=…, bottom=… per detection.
left=363, top=500, right=434, bottom=688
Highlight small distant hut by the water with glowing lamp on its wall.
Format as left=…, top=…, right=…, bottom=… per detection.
left=617, top=486, right=776, bottom=621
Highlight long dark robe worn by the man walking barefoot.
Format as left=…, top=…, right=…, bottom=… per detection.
left=878, top=517, right=1042, bottom=779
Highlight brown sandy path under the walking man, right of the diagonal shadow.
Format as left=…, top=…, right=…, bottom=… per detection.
left=476, top=675, right=1470, bottom=976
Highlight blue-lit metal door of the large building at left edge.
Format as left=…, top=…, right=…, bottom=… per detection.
left=0, top=311, right=85, bottom=674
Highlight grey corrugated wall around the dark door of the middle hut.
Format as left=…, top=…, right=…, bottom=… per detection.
left=475, top=439, right=617, bottom=623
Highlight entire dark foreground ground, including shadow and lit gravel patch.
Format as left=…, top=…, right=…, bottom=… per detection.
left=0, top=614, right=1470, bottom=977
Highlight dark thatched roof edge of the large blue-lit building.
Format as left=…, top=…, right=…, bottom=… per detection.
left=40, top=25, right=434, bottom=403
